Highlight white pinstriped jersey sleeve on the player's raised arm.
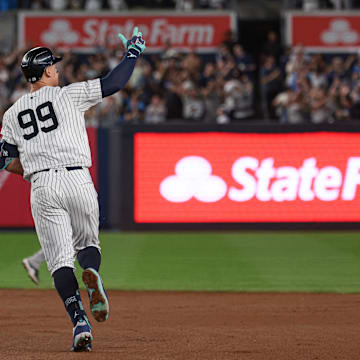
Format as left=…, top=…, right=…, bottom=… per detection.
left=64, top=79, right=102, bottom=111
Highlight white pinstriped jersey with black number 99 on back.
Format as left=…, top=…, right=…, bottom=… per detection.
left=1, top=79, right=102, bottom=181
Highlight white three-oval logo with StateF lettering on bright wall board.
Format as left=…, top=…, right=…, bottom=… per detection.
left=160, top=156, right=360, bottom=203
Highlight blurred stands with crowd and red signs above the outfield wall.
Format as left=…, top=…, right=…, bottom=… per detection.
left=0, top=0, right=360, bottom=128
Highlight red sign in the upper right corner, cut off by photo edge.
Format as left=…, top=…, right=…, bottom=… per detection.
left=286, top=12, right=360, bottom=52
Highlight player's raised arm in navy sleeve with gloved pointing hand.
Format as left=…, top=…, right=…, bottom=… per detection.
left=100, top=27, right=146, bottom=97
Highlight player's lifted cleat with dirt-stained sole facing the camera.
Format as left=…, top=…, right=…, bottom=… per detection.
left=82, top=268, right=109, bottom=322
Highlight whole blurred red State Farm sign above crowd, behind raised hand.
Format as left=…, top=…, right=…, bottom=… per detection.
left=18, top=12, right=235, bottom=52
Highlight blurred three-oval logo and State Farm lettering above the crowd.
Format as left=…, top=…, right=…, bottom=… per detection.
left=41, top=18, right=215, bottom=46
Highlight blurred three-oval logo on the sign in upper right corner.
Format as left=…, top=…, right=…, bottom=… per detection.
left=321, top=19, right=359, bottom=44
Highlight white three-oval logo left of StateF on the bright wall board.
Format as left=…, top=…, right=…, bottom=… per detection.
left=160, top=156, right=227, bottom=203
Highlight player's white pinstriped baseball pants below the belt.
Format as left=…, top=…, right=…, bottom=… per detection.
left=31, top=169, right=100, bottom=274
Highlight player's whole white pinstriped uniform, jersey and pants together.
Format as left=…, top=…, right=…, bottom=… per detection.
left=1, top=79, right=102, bottom=273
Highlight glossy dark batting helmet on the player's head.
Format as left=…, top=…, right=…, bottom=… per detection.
left=21, top=47, right=62, bottom=83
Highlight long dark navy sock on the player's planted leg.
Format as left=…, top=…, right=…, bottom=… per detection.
left=53, top=267, right=90, bottom=326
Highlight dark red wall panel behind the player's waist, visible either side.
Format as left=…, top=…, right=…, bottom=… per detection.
left=0, top=128, right=97, bottom=228
